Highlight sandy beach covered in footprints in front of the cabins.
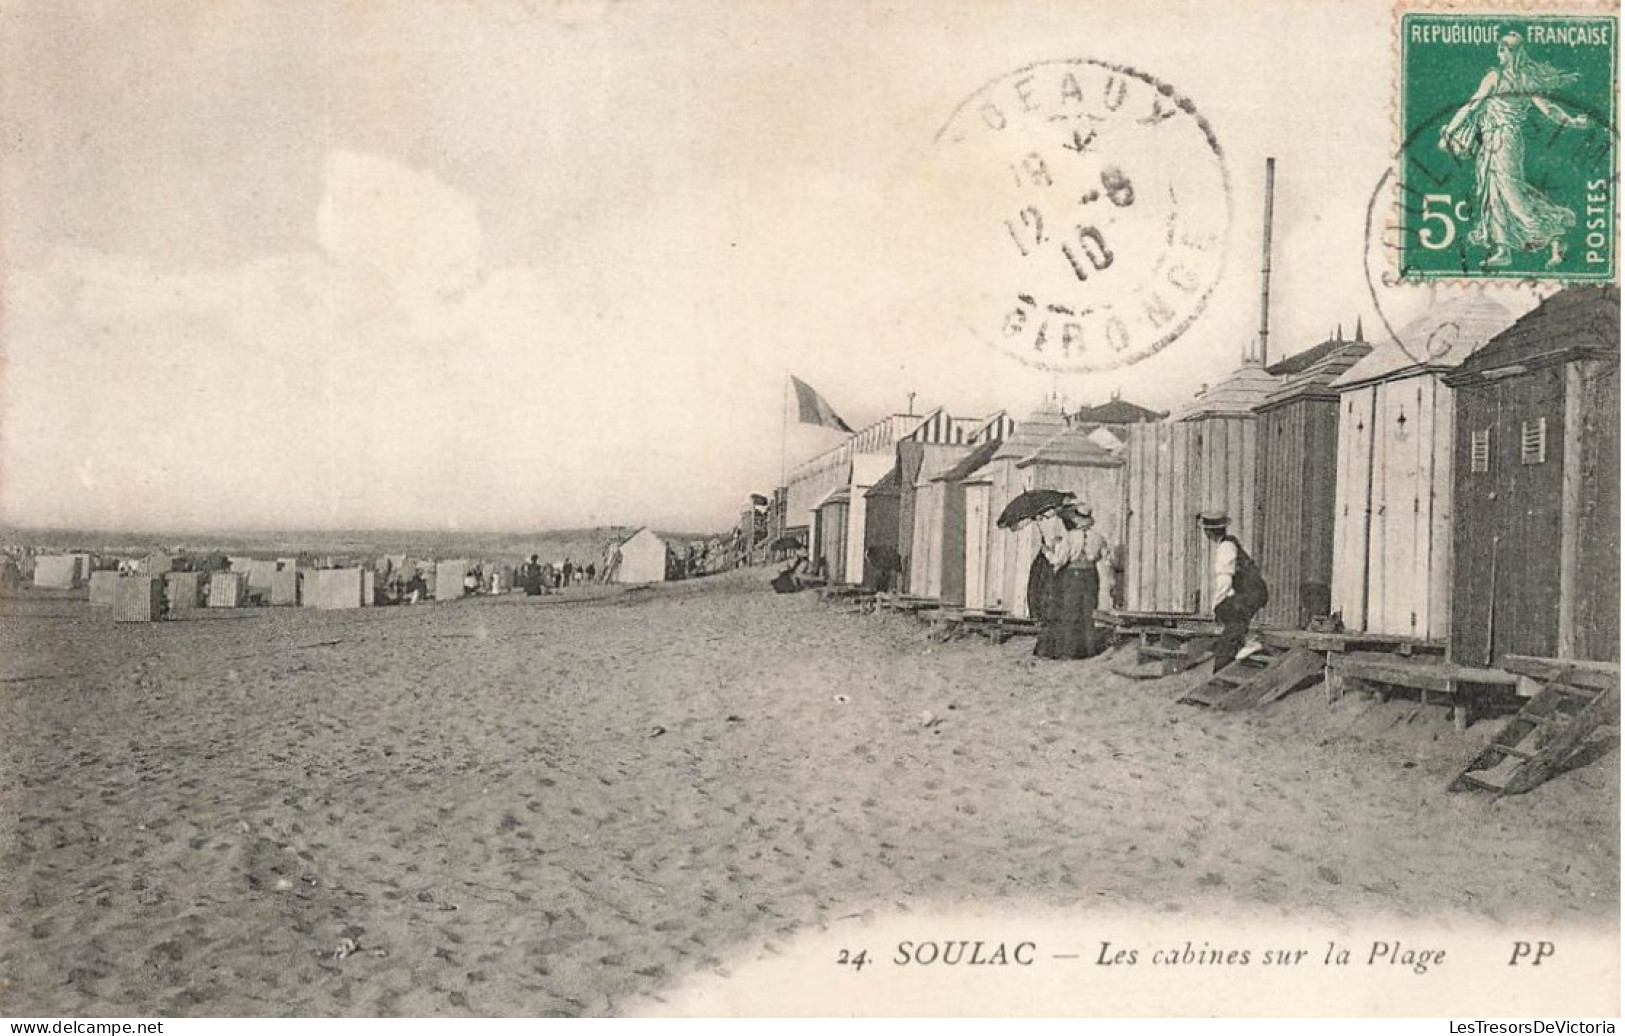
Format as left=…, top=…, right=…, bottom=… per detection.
left=0, top=570, right=1620, bottom=1017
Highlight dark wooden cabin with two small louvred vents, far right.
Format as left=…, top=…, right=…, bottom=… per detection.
left=1445, top=286, right=1620, bottom=664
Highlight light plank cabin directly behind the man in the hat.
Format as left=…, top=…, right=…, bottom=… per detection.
left=1123, top=359, right=1279, bottom=614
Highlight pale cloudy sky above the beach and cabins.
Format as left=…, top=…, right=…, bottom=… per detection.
left=0, top=0, right=1547, bottom=531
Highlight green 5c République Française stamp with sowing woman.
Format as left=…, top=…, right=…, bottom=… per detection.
left=1399, top=10, right=1619, bottom=281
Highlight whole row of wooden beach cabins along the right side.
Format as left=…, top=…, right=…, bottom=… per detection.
left=777, top=286, right=1620, bottom=664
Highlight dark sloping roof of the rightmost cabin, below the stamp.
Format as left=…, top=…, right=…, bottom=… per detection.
left=1445, top=284, right=1620, bottom=385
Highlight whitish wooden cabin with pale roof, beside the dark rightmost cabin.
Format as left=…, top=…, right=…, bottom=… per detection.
left=1331, top=299, right=1511, bottom=643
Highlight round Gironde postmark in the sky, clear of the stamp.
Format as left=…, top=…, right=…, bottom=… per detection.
left=936, top=58, right=1232, bottom=372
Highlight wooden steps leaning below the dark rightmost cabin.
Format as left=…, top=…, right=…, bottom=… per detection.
left=1450, top=656, right=1620, bottom=797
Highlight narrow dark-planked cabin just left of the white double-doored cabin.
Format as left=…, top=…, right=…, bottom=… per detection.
left=1250, top=323, right=1372, bottom=628
